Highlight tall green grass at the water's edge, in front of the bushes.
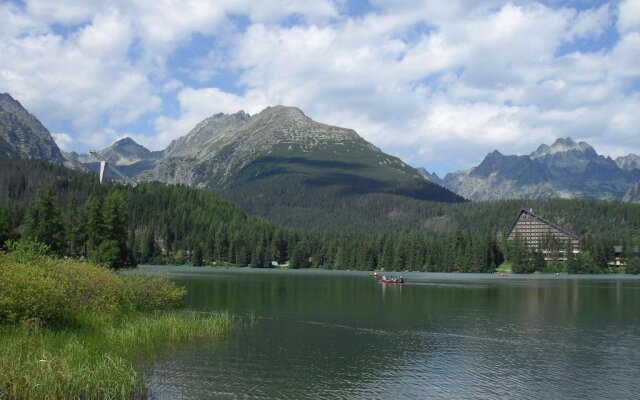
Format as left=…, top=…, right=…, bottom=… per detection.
left=0, top=311, right=232, bottom=399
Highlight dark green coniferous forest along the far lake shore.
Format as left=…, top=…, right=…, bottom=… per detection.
left=0, top=159, right=640, bottom=273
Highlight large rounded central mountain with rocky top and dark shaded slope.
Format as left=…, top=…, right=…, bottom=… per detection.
left=144, top=106, right=464, bottom=229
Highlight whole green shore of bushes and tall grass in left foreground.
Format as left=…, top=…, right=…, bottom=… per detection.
left=0, top=242, right=233, bottom=399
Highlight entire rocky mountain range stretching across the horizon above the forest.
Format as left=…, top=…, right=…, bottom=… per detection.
left=0, top=94, right=640, bottom=209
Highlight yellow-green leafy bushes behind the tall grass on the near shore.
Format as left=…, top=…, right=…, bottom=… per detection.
left=0, top=253, right=186, bottom=326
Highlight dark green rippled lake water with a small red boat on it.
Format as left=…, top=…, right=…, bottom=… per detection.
left=136, top=267, right=640, bottom=399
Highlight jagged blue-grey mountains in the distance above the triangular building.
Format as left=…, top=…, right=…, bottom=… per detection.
left=443, top=137, right=640, bottom=200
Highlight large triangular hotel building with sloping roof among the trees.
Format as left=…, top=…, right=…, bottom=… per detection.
left=507, top=209, right=580, bottom=257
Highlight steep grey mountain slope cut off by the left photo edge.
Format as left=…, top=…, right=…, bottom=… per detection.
left=0, top=93, right=66, bottom=164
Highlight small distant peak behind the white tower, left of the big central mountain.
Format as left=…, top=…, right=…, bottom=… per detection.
left=77, top=137, right=164, bottom=178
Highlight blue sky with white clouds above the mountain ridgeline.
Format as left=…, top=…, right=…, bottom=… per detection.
left=0, top=0, right=640, bottom=175
